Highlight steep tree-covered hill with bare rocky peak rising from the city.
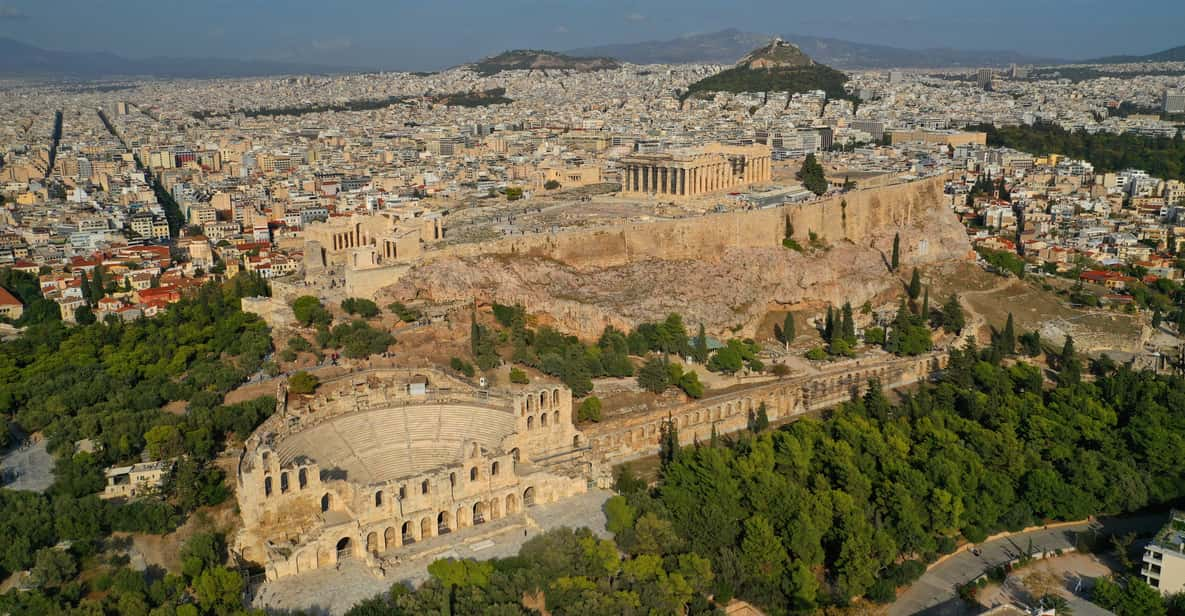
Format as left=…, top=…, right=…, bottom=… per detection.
left=683, top=39, right=851, bottom=98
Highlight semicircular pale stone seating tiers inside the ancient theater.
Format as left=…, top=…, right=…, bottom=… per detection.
left=275, top=404, right=514, bottom=483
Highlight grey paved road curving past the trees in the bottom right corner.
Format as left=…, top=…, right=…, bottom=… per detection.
left=889, top=514, right=1165, bottom=616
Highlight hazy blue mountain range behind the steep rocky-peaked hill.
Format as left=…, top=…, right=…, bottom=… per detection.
left=569, top=28, right=1067, bottom=69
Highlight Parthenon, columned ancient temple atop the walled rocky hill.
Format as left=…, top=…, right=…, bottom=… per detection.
left=620, top=143, right=770, bottom=198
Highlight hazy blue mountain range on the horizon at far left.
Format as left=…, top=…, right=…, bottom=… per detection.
left=0, top=38, right=358, bottom=79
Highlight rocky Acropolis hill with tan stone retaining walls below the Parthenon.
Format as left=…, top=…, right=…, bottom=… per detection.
left=278, top=170, right=971, bottom=336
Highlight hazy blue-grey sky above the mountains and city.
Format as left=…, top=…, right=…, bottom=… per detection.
left=0, top=0, right=1185, bottom=70
